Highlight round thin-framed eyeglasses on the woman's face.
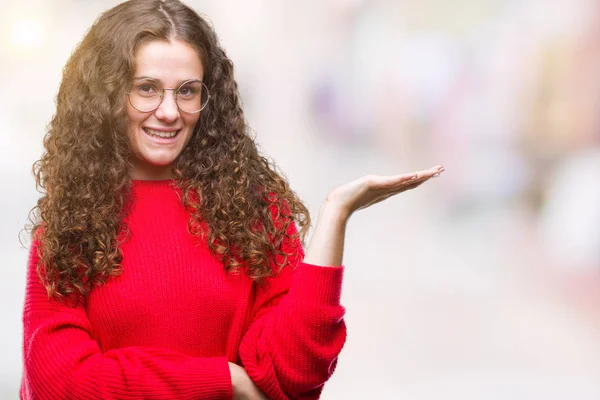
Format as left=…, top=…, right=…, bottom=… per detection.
left=127, top=78, right=210, bottom=114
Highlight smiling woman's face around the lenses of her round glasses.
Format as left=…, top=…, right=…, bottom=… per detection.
left=126, top=40, right=204, bottom=180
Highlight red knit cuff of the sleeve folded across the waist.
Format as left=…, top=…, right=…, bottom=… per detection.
left=186, top=357, right=233, bottom=400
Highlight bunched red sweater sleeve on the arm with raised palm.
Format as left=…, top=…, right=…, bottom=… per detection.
left=239, top=219, right=346, bottom=400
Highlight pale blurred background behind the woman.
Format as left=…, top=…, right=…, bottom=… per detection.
left=0, top=0, right=600, bottom=400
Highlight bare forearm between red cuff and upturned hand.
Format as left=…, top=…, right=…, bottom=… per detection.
left=304, top=201, right=348, bottom=266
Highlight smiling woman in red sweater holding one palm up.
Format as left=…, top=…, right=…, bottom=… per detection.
left=21, top=0, right=443, bottom=399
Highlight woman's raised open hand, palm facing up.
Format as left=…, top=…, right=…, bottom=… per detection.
left=327, top=165, right=444, bottom=219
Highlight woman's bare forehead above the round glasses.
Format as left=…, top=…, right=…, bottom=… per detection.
left=135, top=40, right=204, bottom=85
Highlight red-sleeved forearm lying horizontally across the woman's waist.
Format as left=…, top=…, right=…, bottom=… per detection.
left=21, top=345, right=232, bottom=400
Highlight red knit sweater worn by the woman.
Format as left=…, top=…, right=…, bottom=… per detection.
left=20, top=180, right=346, bottom=400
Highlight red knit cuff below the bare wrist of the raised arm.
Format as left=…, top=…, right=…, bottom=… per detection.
left=288, top=262, right=344, bottom=306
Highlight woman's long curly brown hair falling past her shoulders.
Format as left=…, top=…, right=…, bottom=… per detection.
left=32, top=0, right=310, bottom=299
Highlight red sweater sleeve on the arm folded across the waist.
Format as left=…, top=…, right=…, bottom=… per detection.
left=20, top=240, right=233, bottom=399
